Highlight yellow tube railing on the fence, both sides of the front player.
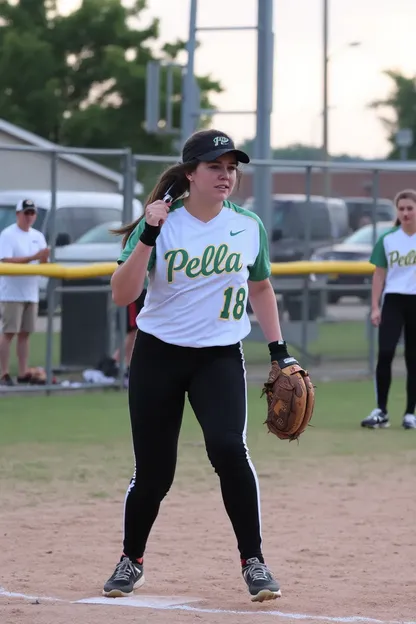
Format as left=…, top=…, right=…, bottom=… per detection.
left=0, top=260, right=374, bottom=279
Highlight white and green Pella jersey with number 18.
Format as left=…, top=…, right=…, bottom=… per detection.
left=119, top=201, right=270, bottom=347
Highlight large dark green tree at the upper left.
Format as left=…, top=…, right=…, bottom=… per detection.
left=0, top=0, right=222, bottom=189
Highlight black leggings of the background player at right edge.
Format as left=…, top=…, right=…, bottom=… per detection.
left=376, top=293, right=416, bottom=414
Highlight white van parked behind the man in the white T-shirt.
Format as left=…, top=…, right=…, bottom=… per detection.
left=0, top=190, right=143, bottom=247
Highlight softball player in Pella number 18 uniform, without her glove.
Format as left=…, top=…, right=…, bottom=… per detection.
left=103, top=130, right=300, bottom=601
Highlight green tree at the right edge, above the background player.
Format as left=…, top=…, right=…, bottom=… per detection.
left=370, top=70, right=416, bottom=160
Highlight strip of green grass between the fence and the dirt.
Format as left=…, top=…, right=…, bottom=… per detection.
left=0, top=380, right=415, bottom=484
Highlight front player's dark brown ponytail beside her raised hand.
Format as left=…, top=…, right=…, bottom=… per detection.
left=110, top=162, right=198, bottom=248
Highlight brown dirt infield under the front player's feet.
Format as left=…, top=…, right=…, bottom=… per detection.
left=0, top=453, right=416, bottom=624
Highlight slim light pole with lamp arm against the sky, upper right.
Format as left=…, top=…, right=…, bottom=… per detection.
left=322, top=0, right=361, bottom=197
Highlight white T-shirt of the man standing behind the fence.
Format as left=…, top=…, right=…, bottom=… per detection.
left=0, top=223, right=47, bottom=303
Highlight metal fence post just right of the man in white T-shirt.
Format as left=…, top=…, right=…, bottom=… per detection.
left=46, top=151, right=58, bottom=394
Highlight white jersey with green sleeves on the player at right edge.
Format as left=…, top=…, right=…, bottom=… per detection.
left=370, top=226, right=416, bottom=295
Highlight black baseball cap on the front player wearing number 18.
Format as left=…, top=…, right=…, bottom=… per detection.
left=182, top=130, right=250, bottom=164
